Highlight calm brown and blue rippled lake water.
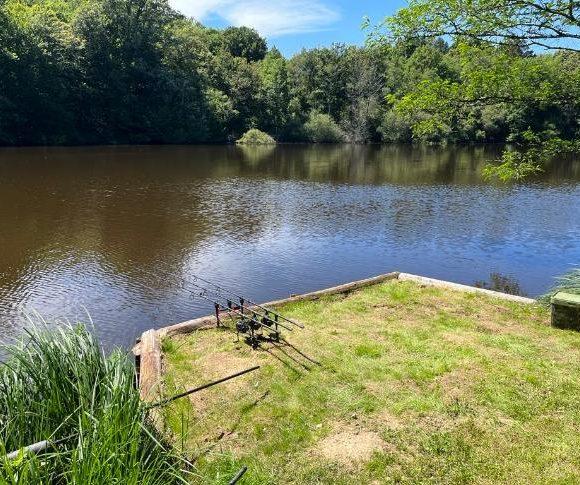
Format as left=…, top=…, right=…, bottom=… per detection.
left=0, top=146, right=580, bottom=352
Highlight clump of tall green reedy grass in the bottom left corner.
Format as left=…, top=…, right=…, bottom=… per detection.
left=0, top=325, right=190, bottom=484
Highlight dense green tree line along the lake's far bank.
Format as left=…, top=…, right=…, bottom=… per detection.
left=0, top=0, right=580, bottom=149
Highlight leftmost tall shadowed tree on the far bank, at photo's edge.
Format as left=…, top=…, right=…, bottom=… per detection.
left=0, top=3, right=80, bottom=144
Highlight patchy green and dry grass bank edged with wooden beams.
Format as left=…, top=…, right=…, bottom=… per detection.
left=163, top=281, right=580, bottom=484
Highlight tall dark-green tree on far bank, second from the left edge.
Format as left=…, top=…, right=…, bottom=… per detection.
left=74, top=0, right=176, bottom=143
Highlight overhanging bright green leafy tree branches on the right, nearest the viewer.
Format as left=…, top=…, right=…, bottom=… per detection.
left=375, top=0, right=580, bottom=180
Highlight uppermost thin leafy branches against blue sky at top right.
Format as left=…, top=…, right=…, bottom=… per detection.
left=386, top=0, right=580, bottom=51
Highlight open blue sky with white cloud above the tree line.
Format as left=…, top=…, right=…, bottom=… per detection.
left=169, top=0, right=406, bottom=56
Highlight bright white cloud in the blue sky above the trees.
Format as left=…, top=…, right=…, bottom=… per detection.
left=170, top=0, right=340, bottom=37
